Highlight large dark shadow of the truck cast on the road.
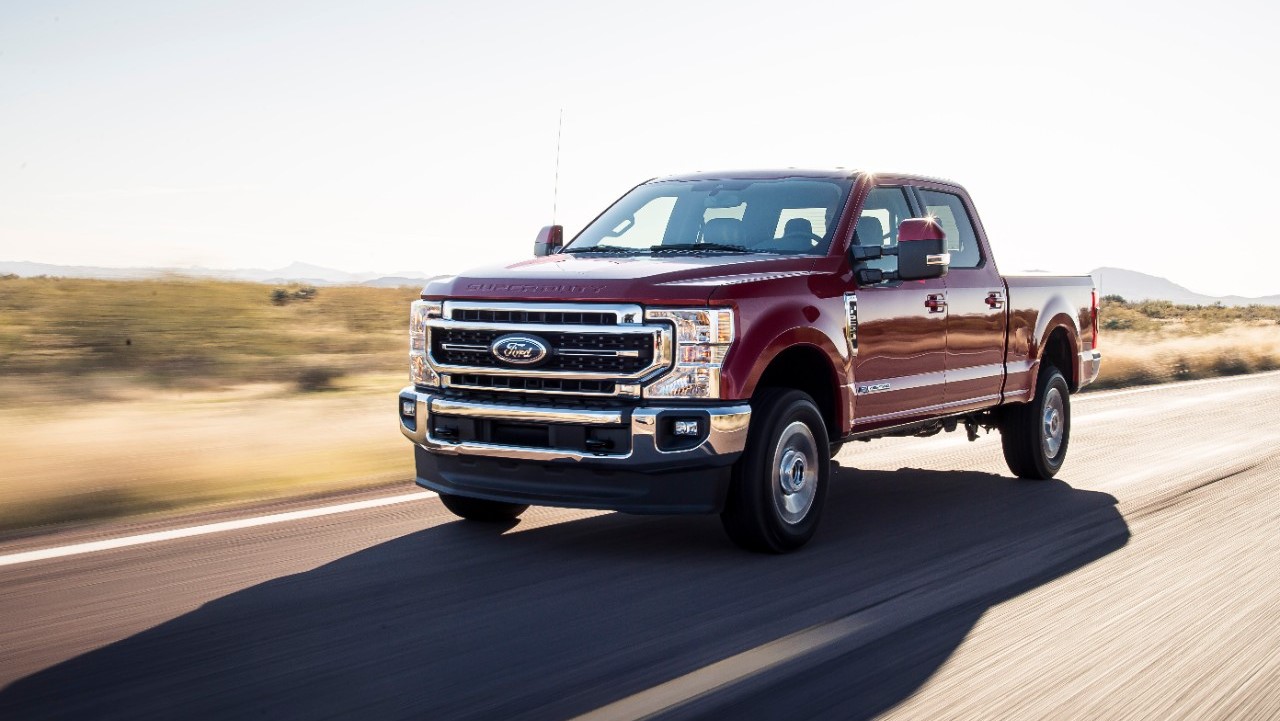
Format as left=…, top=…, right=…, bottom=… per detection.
left=0, top=469, right=1129, bottom=718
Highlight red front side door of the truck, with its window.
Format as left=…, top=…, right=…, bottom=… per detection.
left=854, top=184, right=947, bottom=429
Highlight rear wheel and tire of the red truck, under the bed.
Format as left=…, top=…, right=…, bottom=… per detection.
left=1000, top=365, right=1071, bottom=480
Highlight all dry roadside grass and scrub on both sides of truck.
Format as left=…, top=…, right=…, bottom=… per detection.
left=0, top=277, right=1280, bottom=538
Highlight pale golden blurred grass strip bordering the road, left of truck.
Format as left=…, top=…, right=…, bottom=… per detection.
left=0, top=375, right=413, bottom=531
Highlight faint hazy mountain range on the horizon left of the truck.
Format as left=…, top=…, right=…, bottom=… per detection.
left=0, top=260, right=430, bottom=287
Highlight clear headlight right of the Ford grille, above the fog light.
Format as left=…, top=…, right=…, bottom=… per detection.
left=644, top=307, right=733, bottom=398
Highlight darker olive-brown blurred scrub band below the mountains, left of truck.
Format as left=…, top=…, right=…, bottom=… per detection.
left=0, top=278, right=417, bottom=396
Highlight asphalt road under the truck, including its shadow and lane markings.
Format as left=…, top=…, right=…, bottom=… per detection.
left=0, top=374, right=1280, bottom=720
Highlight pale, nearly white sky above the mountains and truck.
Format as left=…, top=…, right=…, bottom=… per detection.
left=0, top=0, right=1280, bottom=296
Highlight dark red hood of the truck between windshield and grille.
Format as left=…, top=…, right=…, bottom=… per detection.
left=422, top=254, right=820, bottom=305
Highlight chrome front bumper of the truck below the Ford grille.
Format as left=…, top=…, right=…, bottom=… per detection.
left=399, top=387, right=751, bottom=470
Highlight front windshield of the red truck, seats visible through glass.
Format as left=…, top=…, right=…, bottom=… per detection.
left=564, top=178, right=851, bottom=255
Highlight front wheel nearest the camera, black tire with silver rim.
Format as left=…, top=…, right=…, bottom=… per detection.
left=721, top=388, right=831, bottom=553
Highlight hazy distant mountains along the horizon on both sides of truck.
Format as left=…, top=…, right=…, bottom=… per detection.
left=0, top=261, right=1280, bottom=305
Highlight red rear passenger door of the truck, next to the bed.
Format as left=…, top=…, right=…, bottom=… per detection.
left=915, top=183, right=1009, bottom=411
